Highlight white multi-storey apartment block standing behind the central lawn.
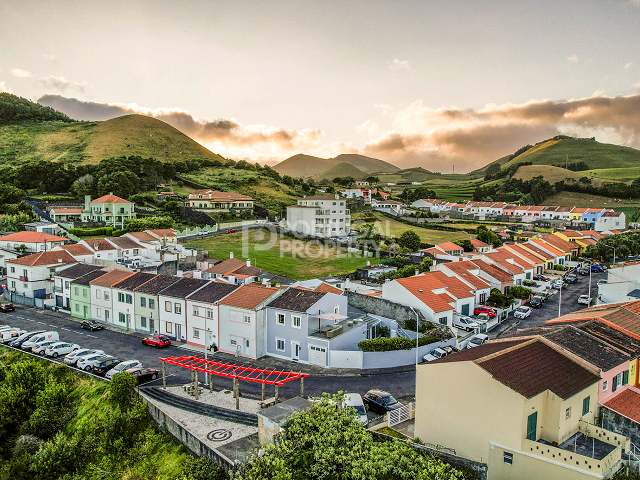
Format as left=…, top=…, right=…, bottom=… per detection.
left=285, top=195, right=351, bottom=238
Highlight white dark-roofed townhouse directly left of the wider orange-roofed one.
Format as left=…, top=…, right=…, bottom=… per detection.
left=186, top=281, right=238, bottom=348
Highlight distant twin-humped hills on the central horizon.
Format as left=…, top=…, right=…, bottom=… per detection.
left=273, top=153, right=400, bottom=179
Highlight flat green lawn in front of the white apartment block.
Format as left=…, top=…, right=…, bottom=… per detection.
left=187, top=229, right=377, bottom=280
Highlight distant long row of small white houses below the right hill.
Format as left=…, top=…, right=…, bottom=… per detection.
left=411, top=198, right=626, bottom=232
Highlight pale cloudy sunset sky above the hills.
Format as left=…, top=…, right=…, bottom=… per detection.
left=0, top=0, right=640, bottom=172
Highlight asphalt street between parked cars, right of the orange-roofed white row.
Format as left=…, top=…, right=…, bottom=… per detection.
left=494, top=273, right=607, bottom=335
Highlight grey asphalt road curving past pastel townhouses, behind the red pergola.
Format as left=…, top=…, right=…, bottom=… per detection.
left=0, top=305, right=415, bottom=399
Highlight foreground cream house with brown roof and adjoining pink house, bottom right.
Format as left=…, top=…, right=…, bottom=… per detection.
left=415, top=301, right=640, bottom=480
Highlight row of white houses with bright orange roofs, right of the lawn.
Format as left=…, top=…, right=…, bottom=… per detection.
left=380, top=234, right=579, bottom=327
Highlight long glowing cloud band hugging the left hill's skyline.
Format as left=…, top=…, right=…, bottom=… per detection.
left=38, top=95, right=323, bottom=158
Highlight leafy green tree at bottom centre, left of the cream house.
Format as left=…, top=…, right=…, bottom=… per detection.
left=234, top=395, right=463, bottom=480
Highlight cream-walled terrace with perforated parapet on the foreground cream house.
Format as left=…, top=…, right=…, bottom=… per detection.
left=522, top=420, right=630, bottom=478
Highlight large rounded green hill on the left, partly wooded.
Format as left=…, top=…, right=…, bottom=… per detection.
left=0, top=93, right=224, bottom=164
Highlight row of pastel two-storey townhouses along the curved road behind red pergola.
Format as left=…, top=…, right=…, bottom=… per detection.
left=54, top=264, right=364, bottom=366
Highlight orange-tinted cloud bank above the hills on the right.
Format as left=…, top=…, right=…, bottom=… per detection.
left=363, top=95, right=640, bottom=171
